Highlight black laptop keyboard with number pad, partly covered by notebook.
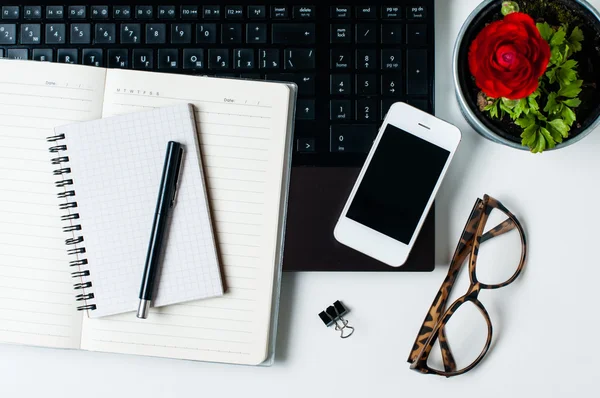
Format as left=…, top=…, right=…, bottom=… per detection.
left=0, top=0, right=434, bottom=166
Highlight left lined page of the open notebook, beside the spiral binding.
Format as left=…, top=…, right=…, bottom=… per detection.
left=0, top=60, right=105, bottom=348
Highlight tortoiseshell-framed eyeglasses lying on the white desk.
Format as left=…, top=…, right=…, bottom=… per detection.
left=408, top=195, right=527, bottom=377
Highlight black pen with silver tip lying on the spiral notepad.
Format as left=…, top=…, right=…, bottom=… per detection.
left=137, top=141, right=183, bottom=319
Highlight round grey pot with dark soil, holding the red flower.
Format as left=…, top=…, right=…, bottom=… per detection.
left=452, top=0, right=600, bottom=150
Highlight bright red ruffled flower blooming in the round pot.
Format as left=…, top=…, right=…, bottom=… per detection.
left=469, top=12, right=550, bottom=100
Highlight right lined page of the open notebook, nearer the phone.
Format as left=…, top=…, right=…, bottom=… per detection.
left=82, top=70, right=290, bottom=364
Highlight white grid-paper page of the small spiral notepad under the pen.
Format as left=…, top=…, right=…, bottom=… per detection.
left=56, top=105, right=223, bottom=319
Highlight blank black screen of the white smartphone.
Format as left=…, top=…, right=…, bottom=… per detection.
left=347, top=124, right=450, bottom=244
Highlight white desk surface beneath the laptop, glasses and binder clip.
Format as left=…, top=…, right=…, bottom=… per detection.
left=0, top=0, right=600, bottom=398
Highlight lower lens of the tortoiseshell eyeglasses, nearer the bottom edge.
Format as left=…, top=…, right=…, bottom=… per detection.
left=427, top=301, right=488, bottom=371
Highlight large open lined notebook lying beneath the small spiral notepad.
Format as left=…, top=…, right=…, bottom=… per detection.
left=0, top=60, right=296, bottom=364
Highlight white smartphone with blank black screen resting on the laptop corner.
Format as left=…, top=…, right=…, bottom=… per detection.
left=334, top=102, right=461, bottom=267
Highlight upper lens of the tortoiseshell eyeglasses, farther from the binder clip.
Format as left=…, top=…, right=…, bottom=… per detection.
left=475, top=209, right=523, bottom=285
